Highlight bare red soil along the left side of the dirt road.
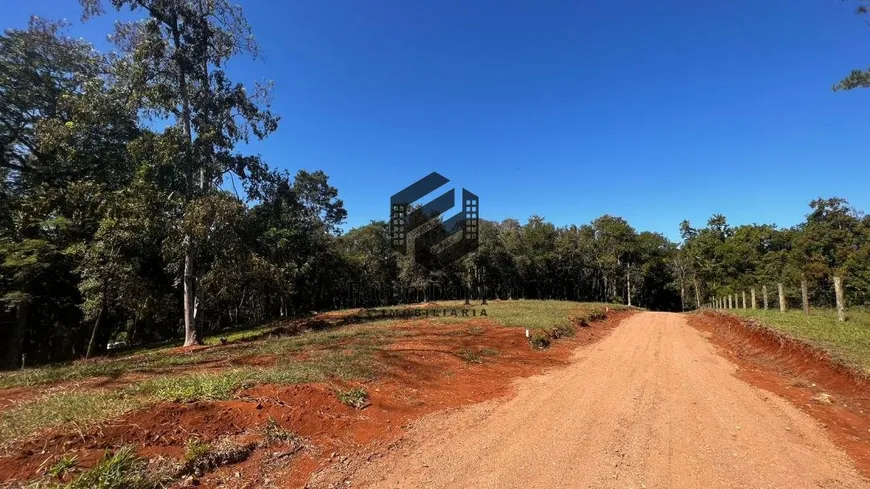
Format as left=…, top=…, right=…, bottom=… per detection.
left=0, top=312, right=632, bottom=488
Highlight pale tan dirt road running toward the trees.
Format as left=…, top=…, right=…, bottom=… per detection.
left=350, top=313, right=870, bottom=488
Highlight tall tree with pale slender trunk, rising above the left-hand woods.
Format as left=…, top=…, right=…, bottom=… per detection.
left=82, top=0, right=278, bottom=345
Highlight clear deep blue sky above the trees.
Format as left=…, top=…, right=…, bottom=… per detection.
left=6, top=0, right=870, bottom=238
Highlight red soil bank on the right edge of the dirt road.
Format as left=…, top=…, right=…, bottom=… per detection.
left=689, top=312, right=870, bottom=478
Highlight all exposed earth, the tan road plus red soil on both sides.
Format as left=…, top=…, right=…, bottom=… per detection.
left=0, top=312, right=870, bottom=488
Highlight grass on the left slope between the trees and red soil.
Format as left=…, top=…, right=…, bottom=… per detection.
left=0, top=300, right=620, bottom=447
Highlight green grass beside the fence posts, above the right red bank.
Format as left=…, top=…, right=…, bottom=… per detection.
left=729, top=309, right=870, bottom=376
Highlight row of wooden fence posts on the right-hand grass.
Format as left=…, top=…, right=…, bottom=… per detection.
left=707, top=277, right=846, bottom=321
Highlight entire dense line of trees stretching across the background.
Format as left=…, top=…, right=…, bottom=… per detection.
left=0, top=0, right=870, bottom=367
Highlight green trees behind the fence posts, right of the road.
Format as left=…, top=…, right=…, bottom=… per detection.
left=677, top=198, right=870, bottom=307
